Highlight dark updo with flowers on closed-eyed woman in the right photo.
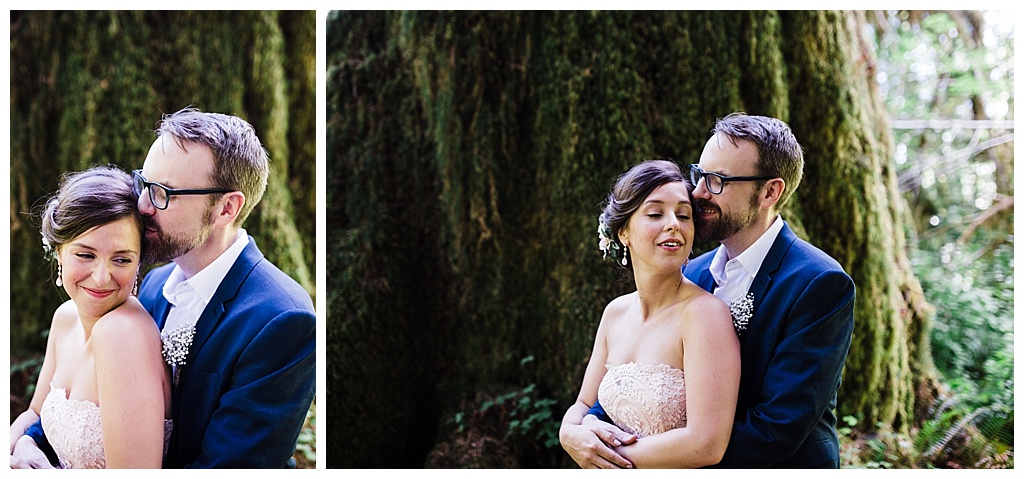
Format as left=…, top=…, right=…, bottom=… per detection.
left=598, top=158, right=693, bottom=266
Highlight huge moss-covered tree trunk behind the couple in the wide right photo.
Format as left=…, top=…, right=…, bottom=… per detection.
left=327, top=11, right=931, bottom=467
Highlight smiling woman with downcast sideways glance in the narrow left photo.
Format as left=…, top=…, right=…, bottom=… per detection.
left=11, top=167, right=171, bottom=469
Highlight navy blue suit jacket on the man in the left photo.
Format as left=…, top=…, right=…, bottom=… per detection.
left=26, top=236, right=316, bottom=468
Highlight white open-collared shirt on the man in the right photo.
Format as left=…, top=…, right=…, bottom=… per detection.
left=709, top=216, right=782, bottom=304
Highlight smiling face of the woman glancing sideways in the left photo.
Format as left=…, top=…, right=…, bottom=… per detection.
left=58, top=218, right=141, bottom=319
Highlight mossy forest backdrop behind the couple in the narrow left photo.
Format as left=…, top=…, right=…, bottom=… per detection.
left=9, top=11, right=323, bottom=468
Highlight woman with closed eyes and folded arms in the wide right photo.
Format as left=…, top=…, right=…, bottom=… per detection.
left=559, top=160, right=739, bottom=468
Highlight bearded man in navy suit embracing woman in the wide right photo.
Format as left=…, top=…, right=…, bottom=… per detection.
left=563, top=114, right=854, bottom=469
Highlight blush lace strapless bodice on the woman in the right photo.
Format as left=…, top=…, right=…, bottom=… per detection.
left=597, top=362, right=686, bottom=437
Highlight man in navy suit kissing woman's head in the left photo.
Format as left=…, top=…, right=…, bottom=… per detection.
left=18, top=108, right=316, bottom=468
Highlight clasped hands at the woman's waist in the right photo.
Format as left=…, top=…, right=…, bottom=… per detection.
left=558, top=415, right=637, bottom=469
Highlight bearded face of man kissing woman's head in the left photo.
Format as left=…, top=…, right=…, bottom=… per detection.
left=138, top=134, right=214, bottom=263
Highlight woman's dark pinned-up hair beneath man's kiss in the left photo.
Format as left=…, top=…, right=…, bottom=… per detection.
left=39, top=166, right=144, bottom=258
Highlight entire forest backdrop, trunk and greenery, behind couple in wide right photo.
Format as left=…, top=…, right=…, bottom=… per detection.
left=327, top=10, right=1014, bottom=468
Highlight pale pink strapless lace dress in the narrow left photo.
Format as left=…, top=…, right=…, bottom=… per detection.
left=39, top=388, right=173, bottom=469
